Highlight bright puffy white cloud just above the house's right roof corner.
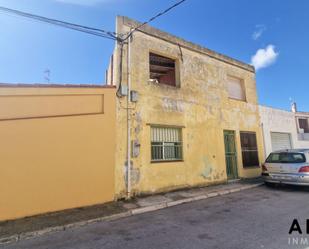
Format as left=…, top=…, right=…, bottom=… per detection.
left=251, top=44, right=279, bottom=70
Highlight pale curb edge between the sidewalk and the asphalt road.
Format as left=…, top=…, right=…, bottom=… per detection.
left=0, top=183, right=264, bottom=245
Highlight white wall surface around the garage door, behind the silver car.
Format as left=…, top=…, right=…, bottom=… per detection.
left=259, top=106, right=309, bottom=155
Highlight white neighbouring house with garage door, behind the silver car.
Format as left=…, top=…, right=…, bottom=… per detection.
left=259, top=103, right=309, bottom=156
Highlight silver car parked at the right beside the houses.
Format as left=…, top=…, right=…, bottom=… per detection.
left=262, top=149, right=309, bottom=186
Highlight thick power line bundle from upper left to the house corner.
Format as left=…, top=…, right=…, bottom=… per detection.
left=0, top=6, right=119, bottom=40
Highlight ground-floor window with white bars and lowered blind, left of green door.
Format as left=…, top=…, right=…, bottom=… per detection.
left=151, top=127, right=182, bottom=161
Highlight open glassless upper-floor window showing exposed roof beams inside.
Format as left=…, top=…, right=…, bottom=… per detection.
left=149, top=53, right=176, bottom=86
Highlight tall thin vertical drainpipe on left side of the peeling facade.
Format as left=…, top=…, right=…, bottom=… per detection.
left=127, top=30, right=131, bottom=199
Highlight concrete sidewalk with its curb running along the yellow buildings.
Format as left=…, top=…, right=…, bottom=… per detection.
left=0, top=179, right=263, bottom=245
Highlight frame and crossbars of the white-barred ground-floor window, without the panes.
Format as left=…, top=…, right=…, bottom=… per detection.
left=150, top=125, right=184, bottom=163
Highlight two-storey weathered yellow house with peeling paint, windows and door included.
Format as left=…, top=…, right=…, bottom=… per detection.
left=107, top=17, right=264, bottom=198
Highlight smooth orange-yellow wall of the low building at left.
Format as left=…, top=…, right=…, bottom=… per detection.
left=0, top=86, right=115, bottom=220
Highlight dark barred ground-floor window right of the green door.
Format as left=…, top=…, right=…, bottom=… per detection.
left=240, top=132, right=259, bottom=168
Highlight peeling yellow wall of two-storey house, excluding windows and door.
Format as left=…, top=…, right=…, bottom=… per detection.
left=114, top=17, right=264, bottom=197
